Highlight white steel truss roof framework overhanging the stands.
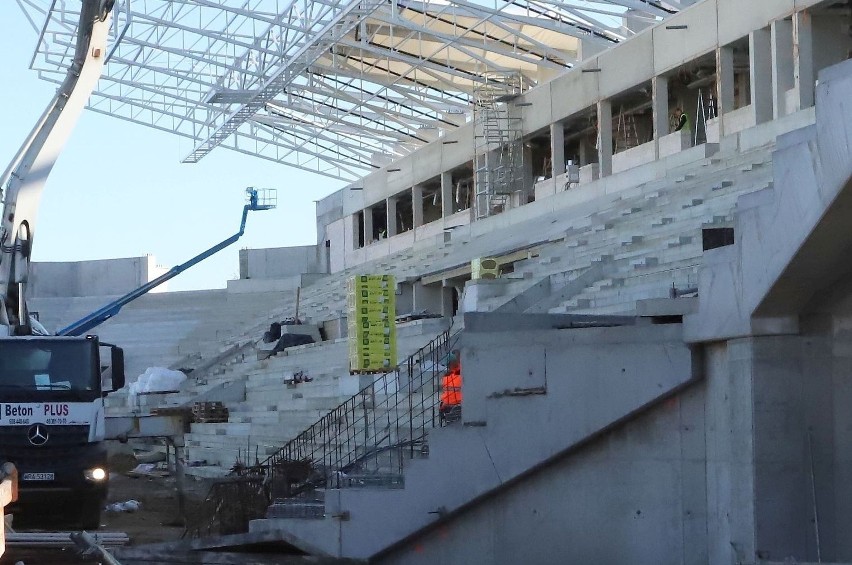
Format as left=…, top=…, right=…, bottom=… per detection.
left=19, top=0, right=680, bottom=180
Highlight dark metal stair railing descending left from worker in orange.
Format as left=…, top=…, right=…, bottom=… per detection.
left=198, top=330, right=460, bottom=536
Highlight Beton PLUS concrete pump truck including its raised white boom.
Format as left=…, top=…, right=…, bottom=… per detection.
left=0, top=0, right=130, bottom=529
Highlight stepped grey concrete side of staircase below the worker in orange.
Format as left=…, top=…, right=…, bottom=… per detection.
left=250, top=315, right=697, bottom=558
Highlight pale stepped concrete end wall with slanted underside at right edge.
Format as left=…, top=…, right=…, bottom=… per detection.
left=685, top=57, right=852, bottom=341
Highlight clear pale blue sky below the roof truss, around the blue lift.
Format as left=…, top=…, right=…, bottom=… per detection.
left=0, top=5, right=344, bottom=290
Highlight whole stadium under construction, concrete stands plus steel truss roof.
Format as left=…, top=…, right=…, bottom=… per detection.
left=8, top=0, right=852, bottom=565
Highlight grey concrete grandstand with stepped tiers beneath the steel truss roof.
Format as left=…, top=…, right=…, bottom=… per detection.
left=15, top=0, right=852, bottom=564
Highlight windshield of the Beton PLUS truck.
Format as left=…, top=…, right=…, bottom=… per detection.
left=0, top=339, right=100, bottom=393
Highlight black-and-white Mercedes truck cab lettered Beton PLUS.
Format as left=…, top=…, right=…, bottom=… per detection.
left=0, top=336, right=124, bottom=529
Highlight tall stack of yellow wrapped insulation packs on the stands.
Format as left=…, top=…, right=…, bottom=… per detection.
left=347, top=275, right=397, bottom=372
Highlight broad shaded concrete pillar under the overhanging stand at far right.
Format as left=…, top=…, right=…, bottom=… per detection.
left=746, top=336, right=828, bottom=561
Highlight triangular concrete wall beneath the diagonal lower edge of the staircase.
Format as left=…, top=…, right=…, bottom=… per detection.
left=376, top=378, right=707, bottom=565
